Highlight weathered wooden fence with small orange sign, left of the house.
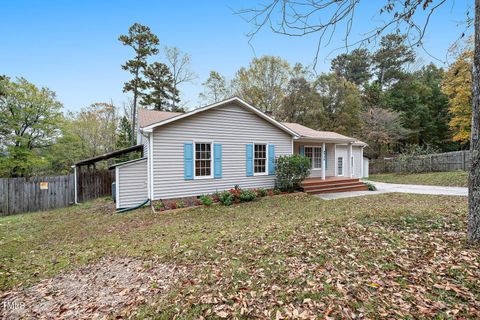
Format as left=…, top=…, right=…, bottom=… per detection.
left=0, top=169, right=115, bottom=216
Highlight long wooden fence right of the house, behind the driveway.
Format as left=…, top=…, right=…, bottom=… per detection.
left=369, top=150, right=471, bottom=174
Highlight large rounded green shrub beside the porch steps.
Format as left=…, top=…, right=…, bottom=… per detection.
left=276, top=154, right=310, bottom=192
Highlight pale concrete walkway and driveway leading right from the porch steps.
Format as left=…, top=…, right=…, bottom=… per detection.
left=318, top=180, right=468, bottom=200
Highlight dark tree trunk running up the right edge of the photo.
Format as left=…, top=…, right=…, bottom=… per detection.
left=467, top=0, right=480, bottom=243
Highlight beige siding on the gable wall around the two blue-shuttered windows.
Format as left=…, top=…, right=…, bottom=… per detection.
left=153, top=103, right=292, bottom=199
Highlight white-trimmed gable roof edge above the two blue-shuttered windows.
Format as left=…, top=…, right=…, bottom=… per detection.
left=141, top=97, right=298, bottom=137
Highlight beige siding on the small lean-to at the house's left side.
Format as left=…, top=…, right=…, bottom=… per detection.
left=115, top=159, right=148, bottom=208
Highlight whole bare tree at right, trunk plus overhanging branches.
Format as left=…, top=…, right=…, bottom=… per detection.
left=237, top=0, right=480, bottom=243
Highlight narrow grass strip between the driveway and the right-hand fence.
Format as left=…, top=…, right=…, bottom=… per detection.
left=368, top=171, right=468, bottom=187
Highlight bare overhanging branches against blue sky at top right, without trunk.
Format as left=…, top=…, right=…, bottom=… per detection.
left=236, top=0, right=473, bottom=66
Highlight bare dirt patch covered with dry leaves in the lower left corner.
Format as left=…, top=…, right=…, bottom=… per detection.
left=0, top=258, right=184, bottom=319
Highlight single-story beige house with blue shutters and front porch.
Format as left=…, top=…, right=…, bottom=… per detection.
left=111, top=97, right=368, bottom=208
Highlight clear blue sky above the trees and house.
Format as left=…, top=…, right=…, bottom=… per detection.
left=0, top=0, right=471, bottom=111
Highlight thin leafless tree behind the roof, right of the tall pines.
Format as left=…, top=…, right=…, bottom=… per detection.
left=164, top=47, right=197, bottom=111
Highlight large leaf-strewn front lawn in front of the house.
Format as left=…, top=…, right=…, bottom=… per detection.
left=0, top=194, right=480, bottom=319
